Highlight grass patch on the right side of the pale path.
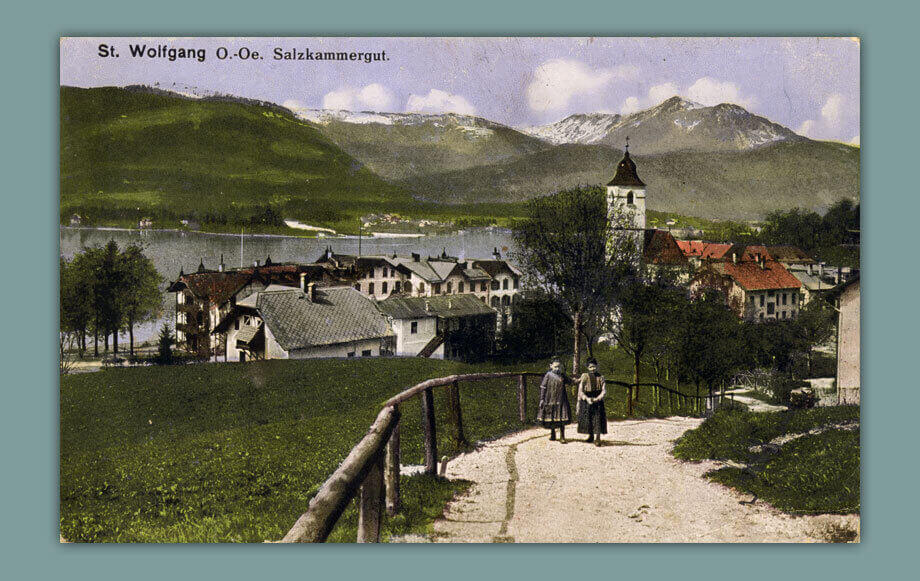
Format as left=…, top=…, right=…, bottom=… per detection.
left=674, top=406, right=860, bottom=514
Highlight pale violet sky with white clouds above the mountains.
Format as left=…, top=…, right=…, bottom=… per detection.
left=60, top=37, right=860, bottom=144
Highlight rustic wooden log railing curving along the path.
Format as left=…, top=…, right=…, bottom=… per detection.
left=281, top=371, right=714, bottom=543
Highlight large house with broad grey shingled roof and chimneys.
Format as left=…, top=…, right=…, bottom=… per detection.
left=213, top=284, right=395, bottom=361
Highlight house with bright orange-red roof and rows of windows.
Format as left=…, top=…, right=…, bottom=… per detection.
left=690, top=253, right=802, bottom=321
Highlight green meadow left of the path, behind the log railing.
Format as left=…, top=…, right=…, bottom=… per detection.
left=61, top=344, right=704, bottom=542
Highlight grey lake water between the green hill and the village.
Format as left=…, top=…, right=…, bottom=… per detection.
left=61, top=227, right=511, bottom=342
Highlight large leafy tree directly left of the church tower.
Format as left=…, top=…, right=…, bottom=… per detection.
left=512, top=186, right=638, bottom=374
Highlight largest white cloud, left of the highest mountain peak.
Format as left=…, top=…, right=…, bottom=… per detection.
left=526, top=59, right=639, bottom=112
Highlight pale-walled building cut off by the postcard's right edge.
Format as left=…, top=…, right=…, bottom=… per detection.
left=828, top=274, right=861, bottom=405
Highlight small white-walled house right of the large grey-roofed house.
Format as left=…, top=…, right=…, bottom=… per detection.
left=378, top=294, right=496, bottom=360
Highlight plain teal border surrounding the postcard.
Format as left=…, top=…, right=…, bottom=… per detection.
left=0, top=0, right=920, bottom=580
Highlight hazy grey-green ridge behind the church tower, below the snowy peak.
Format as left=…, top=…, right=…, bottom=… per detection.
left=404, top=141, right=859, bottom=219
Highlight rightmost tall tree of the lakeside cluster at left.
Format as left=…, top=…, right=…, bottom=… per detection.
left=116, top=244, right=163, bottom=355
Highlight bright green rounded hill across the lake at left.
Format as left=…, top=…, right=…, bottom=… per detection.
left=60, top=87, right=413, bottom=231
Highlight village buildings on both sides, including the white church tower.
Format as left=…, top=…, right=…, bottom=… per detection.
left=167, top=145, right=859, bottom=403
